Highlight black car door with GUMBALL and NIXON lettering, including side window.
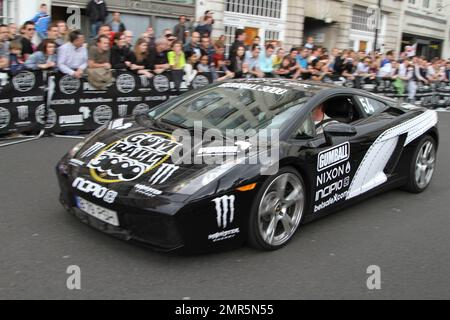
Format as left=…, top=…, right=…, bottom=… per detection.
left=294, top=96, right=376, bottom=215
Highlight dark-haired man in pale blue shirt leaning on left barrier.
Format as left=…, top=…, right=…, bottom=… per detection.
left=58, top=30, right=88, bottom=79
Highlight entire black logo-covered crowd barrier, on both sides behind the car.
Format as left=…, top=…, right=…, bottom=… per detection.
left=0, top=70, right=450, bottom=135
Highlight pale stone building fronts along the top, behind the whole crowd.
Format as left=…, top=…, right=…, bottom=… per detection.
left=6, top=0, right=450, bottom=58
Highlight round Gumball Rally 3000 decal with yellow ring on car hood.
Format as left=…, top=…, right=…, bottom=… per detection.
left=87, top=132, right=181, bottom=183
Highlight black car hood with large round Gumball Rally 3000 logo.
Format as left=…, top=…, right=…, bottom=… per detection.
left=69, top=119, right=253, bottom=199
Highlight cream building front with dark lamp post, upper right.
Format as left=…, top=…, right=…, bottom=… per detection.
left=304, top=0, right=401, bottom=52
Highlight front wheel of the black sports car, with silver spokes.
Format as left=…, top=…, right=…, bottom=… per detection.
left=248, top=167, right=307, bottom=251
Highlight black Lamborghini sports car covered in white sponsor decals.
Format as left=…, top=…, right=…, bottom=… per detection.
left=57, top=80, right=439, bottom=251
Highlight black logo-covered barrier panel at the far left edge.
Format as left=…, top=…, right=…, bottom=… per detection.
left=0, top=71, right=46, bottom=135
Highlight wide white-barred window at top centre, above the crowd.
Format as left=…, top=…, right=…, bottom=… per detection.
left=225, top=0, right=283, bottom=19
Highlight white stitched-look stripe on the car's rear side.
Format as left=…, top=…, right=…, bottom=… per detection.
left=347, top=110, right=438, bottom=200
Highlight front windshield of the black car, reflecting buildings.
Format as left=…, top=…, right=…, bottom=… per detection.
left=150, top=82, right=311, bottom=132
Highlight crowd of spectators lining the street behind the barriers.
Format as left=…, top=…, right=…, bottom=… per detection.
left=0, top=0, right=450, bottom=100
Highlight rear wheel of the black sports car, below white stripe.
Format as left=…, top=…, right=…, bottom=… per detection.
left=404, top=135, right=437, bottom=194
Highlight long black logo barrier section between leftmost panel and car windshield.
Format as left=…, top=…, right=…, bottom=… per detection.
left=47, top=70, right=212, bottom=133
